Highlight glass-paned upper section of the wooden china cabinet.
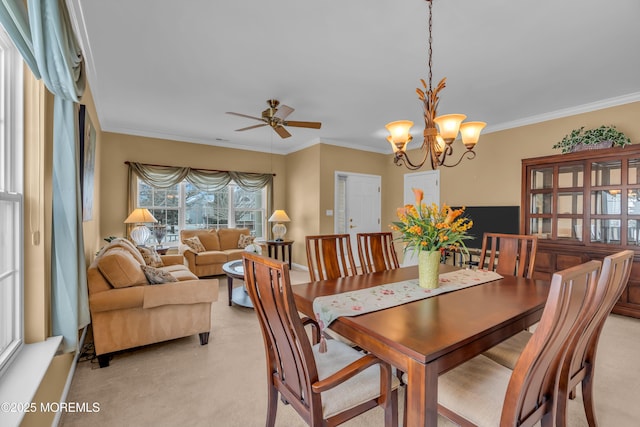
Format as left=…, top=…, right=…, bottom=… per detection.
left=523, top=149, right=640, bottom=250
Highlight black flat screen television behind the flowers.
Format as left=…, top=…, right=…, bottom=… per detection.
left=452, top=206, right=520, bottom=249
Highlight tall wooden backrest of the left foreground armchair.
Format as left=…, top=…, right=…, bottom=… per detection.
left=243, top=252, right=322, bottom=419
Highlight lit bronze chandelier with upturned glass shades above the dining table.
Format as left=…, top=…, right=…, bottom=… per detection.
left=385, top=0, right=487, bottom=170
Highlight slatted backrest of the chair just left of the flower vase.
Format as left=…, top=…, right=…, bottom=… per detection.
left=357, top=232, right=400, bottom=273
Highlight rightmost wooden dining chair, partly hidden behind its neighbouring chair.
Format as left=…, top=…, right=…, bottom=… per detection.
left=484, top=250, right=634, bottom=427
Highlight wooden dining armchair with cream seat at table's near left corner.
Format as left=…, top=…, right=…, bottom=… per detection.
left=243, top=252, right=399, bottom=427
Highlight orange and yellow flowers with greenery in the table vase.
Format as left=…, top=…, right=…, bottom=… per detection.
left=391, top=188, right=473, bottom=252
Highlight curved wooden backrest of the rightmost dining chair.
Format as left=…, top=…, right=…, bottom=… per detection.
left=557, top=250, right=635, bottom=425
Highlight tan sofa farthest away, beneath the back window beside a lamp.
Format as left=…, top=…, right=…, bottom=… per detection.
left=180, top=228, right=251, bottom=277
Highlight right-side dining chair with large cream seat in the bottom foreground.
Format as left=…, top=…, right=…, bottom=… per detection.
left=438, top=261, right=601, bottom=427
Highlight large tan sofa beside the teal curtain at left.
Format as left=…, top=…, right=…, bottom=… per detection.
left=87, top=239, right=218, bottom=367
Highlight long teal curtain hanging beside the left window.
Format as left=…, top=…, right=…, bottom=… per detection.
left=0, top=0, right=89, bottom=352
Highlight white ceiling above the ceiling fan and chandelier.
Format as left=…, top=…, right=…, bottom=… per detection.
left=68, top=0, right=640, bottom=153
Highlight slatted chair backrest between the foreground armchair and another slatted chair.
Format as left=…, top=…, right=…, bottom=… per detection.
left=306, top=234, right=358, bottom=282
